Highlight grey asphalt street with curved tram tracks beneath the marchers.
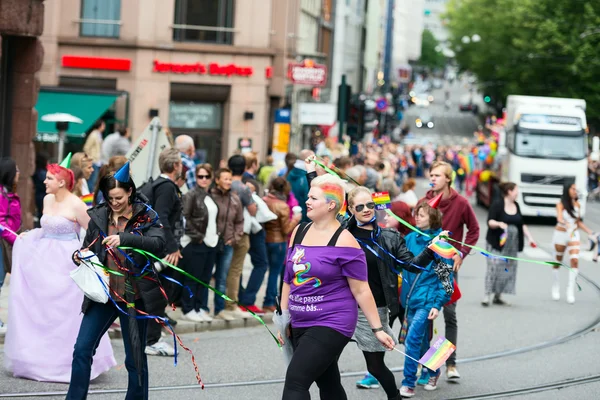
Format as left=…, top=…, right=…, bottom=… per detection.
left=0, top=189, right=600, bottom=400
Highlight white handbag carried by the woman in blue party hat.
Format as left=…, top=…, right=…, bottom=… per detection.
left=69, top=250, right=110, bottom=304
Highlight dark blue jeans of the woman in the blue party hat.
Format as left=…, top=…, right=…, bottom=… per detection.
left=67, top=300, right=148, bottom=400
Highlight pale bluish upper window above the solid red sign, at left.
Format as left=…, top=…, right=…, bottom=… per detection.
left=80, top=0, right=121, bottom=38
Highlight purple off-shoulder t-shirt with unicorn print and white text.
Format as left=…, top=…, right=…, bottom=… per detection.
left=283, top=244, right=367, bottom=337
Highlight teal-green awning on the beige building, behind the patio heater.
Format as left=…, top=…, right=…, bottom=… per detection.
left=35, top=90, right=118, bottom=142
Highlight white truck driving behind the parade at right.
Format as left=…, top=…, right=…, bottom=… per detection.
left=477, top=95, right=588, bottom=217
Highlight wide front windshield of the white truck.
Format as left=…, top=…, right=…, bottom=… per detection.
left=514, top=129, right=587, bottom=160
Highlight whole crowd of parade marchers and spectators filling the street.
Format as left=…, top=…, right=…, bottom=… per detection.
left=0, top=117, right=593, bottom=399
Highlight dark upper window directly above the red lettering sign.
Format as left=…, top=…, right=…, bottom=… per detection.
left=173, top=0, right=234, bottom=44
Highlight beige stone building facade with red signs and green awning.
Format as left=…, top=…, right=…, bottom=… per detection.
left=37, top=0, right=290, bottom=165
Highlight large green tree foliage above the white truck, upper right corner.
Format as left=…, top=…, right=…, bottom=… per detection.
left=445, top=0, right=600, bottom=125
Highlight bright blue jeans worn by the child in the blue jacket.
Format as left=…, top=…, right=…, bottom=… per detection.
left=402, top=308, right=440, bottom=388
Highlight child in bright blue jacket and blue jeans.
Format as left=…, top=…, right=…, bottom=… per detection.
left=400, top=202, right=452, bottom=397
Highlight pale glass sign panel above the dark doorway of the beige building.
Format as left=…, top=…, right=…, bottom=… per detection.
left=169, top=102, right=222, bottom=129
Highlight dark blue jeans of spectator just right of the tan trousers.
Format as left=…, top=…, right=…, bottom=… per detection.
left=239, top=229, right=269, bottom=306
